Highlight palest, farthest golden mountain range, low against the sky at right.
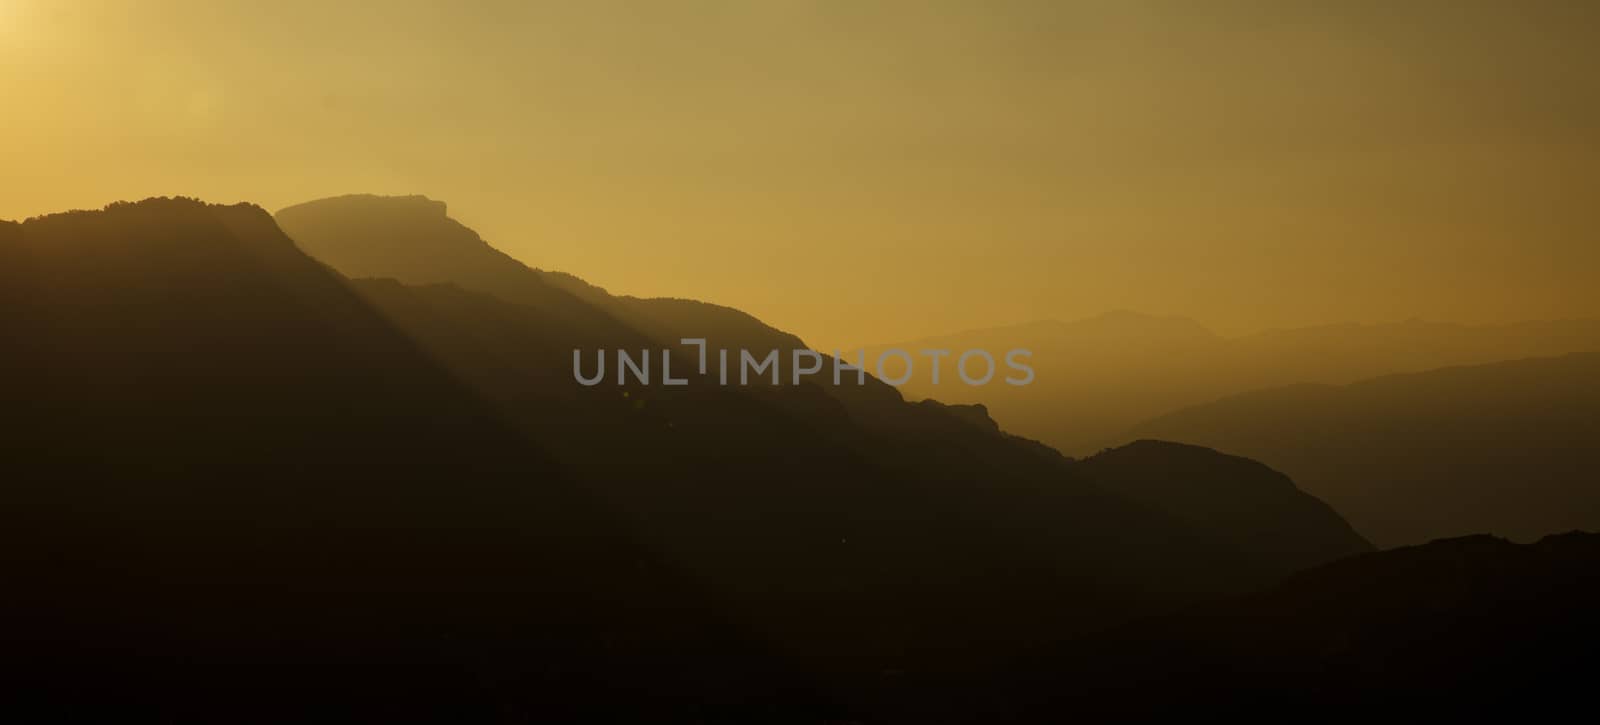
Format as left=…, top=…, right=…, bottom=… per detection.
left=867, top=312, right=1600, bottom=457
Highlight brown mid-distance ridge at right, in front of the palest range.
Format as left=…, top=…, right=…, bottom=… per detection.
left=1130, top=354, right=1600, bottom=546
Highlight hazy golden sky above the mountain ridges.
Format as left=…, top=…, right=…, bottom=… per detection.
left=0, top=0, right=1600, bottom=344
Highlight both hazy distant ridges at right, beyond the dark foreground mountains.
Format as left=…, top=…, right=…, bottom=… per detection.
left=870, top=312, right=1600, bottom=546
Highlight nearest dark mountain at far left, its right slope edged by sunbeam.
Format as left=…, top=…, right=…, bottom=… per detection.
left=0, top=198, right=798, bottom=722
